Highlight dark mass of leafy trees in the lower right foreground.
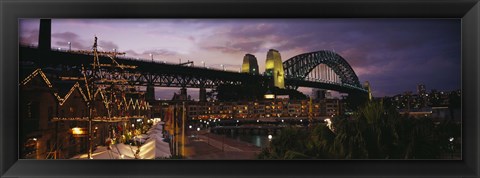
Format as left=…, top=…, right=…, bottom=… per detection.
left=259, top=102, right=450, bottom=159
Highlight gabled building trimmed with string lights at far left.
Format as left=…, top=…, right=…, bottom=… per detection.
left=19, top=67, right=149, bottom=159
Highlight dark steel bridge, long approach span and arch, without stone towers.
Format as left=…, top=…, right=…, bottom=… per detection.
left=19, top=46, right=368, bottom=94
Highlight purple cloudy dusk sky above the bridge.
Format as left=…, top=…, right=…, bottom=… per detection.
left=19, top=19, right=461, bottom=99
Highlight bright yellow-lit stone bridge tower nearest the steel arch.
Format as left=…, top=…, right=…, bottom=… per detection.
left=265, top=49, right=285, bottom=89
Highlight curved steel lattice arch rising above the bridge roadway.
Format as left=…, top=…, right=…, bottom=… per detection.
left=283, top=50, right=362, bottom=88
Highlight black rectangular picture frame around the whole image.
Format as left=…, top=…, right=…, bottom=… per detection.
left=0, top=0, right=480, bottom=177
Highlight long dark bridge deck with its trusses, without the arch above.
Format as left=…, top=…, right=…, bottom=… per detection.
left=19, top=46, right=367, bottom=94
